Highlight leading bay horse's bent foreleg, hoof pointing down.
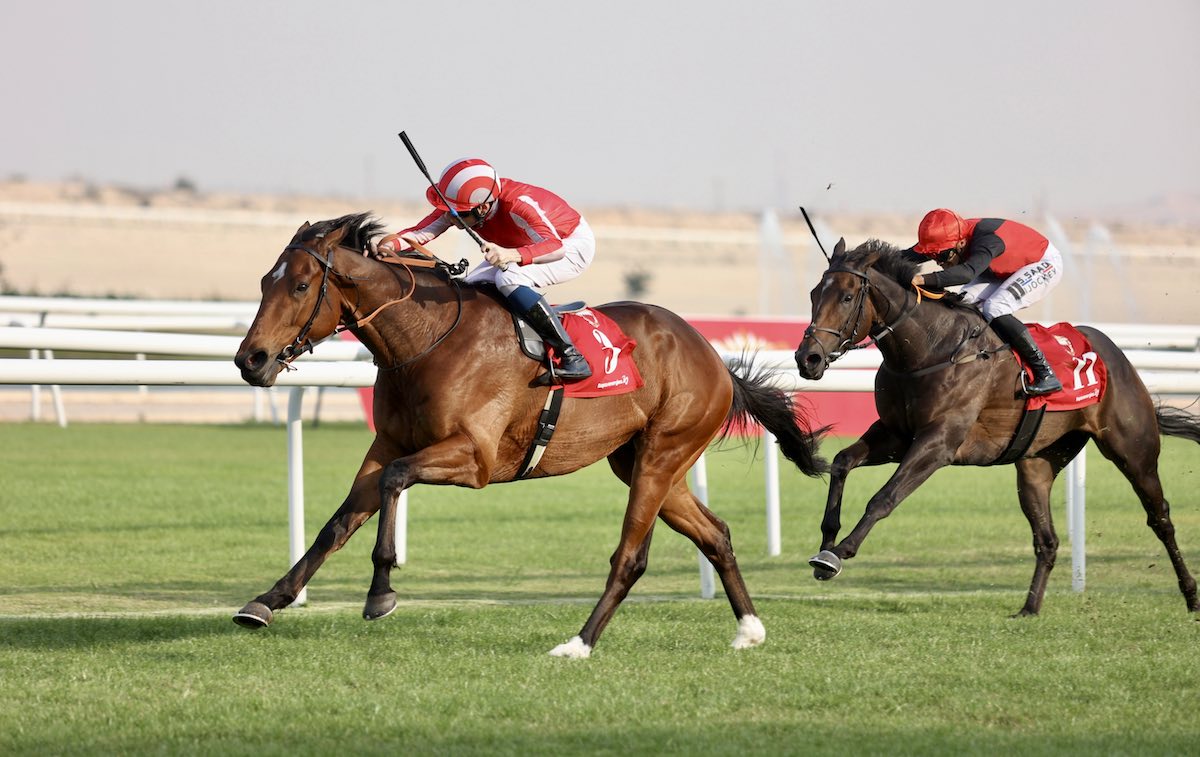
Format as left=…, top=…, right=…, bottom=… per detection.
left=362, top=434, right=490, bottom=620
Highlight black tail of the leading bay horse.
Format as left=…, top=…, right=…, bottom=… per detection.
left=719, top=359, right=829, bottom=477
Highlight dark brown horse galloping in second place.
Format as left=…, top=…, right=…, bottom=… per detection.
left=796, top=240, right=1200, bottom=617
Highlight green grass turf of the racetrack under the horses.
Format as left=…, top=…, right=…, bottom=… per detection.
left=0, top=425, right=1200, bottom=755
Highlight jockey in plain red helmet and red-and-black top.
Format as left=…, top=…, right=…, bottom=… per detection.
left=912, top=208, right=1062, bottom=397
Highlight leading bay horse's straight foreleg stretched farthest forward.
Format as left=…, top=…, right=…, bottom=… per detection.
left=233, top=463, right=379, bottom=629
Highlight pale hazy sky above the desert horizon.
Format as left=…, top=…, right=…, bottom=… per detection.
left=0, top=0, right=1200, bottom=215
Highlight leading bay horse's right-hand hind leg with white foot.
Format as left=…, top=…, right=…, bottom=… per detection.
left=659, top=480, right=767, bottom=649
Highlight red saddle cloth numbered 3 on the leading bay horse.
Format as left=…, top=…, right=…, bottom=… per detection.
left=562, top=307, right=644, bottom=397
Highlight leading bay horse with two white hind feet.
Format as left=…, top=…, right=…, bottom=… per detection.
left=234, top=214, right=828, bottom=657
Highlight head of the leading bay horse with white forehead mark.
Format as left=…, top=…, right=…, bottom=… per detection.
left=234, top=214, right=364, bottom=386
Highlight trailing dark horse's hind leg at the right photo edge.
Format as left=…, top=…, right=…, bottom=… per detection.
left=1096, top=434, right=1200, bottom=612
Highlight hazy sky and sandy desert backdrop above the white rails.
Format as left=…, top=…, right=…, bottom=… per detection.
left=0, top=0, right=1200, bottom=424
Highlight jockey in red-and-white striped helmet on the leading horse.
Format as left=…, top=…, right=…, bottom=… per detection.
left=377, top=158, right=596, bottom=381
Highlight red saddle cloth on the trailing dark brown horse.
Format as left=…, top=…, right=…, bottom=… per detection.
left=1014, top=323, right=1109, bottom=411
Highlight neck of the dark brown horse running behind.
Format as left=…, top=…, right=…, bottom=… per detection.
left=870, top=272, right=982, bottom=368
